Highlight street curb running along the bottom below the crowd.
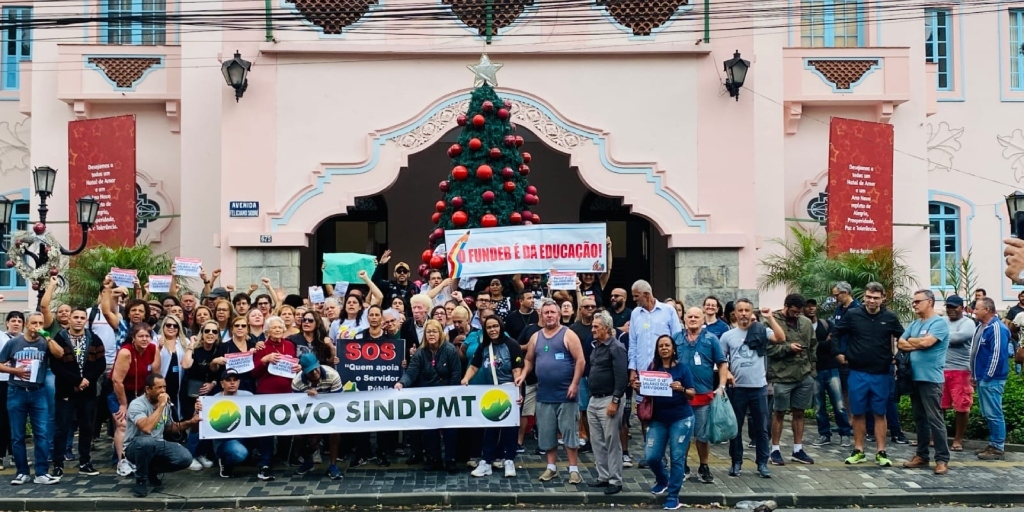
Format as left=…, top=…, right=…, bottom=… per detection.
left=6, top=489, right=1024, bottom=512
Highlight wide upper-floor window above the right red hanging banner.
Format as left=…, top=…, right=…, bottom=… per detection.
left=800, top=0, right=864, bottom=48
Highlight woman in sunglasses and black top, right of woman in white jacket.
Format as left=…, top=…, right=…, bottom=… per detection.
left=181, top=321, right=227, bottom=468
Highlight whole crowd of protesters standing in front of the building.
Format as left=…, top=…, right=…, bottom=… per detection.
left=0, top=246, right=1011, bottom=510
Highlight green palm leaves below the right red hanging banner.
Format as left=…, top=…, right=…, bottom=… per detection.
left=758, top=226, right=918, bottom=321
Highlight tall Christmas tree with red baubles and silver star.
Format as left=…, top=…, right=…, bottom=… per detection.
left=420, top=55, right=541, bottom=276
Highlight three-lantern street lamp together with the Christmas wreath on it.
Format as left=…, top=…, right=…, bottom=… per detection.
left=0, top=166, right=99, bottom=307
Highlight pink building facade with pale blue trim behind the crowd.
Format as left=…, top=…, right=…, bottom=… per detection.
left=0, top=0, right=1007, bottom=309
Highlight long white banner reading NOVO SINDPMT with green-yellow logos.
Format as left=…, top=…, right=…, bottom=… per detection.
left=199, top=386, right=519, bottom=439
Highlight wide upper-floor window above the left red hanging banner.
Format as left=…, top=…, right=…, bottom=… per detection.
left=100, top=0, right=167, bottom=45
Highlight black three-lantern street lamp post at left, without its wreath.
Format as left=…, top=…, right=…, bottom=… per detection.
left=0, top=166, right=99, bottom=308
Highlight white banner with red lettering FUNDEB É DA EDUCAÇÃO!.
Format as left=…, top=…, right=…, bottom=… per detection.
left=444, top=224, right=607, bottom=278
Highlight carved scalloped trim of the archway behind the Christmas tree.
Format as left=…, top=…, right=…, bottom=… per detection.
left=268, top=89, right=708, bottom=248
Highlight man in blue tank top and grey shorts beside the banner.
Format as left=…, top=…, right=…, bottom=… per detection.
left=516, top=299, right=587, bottom=484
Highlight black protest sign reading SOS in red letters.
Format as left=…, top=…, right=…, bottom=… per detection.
left=338, top=340, right=406, bottom=391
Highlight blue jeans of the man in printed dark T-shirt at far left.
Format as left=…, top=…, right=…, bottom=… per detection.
left=7, top=384, right=50, bottom=476
